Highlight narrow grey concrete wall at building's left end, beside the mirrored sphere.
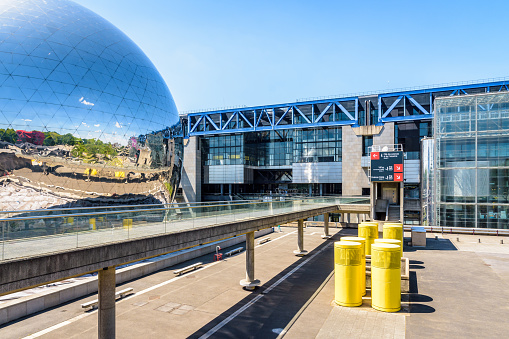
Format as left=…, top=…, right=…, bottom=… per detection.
left=180, top=137, right=202, bottom=202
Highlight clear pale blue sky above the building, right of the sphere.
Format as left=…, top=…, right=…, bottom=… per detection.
left=76, top=0, right=509, bottom=111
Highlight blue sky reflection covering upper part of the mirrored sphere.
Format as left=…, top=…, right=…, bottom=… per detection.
left=0, top=0, right=178, bottom=145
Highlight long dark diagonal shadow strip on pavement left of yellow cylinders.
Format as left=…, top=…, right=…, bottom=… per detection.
left=190, top=230, right=352, bottom=338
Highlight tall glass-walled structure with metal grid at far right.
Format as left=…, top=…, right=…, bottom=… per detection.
left=433, top=92, right=509, bottom=229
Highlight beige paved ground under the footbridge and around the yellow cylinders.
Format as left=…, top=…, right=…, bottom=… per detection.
left=0, top=227, right=509, bottom=338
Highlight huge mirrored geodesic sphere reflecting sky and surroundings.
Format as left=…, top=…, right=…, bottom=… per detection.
left=0, top=0, right=183, bottom=211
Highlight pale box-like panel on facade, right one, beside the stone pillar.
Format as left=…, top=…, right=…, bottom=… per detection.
left=292, top=162, right=342, bottom=184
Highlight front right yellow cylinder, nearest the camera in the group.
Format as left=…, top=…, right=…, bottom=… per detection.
left=371, top=244, right=401, bottom=312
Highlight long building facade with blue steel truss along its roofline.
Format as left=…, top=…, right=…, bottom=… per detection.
left=182, top=79, right=509, bottom=224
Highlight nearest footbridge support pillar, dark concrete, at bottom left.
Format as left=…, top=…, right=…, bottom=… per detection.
left=98, top=267, right=115, bottom=339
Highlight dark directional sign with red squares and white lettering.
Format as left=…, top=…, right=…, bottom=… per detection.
left=371, top=152, right=403, bottom=181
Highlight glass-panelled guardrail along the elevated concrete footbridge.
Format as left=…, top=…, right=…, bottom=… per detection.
left=0, top=198, right=368, bottom=260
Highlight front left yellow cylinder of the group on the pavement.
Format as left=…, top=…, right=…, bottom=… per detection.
left=334, top=241, right=362, bottom=307
